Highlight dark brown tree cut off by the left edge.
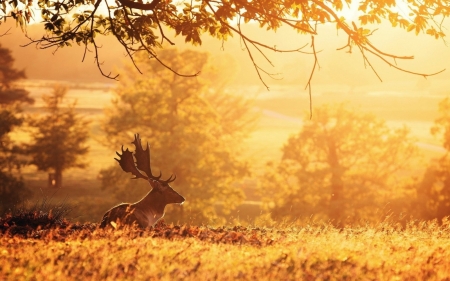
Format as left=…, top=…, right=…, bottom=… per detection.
left=0, top=45, right=33, bottom=214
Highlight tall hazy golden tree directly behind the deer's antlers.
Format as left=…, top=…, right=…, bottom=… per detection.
left=101, top=47, right=254, bottom=222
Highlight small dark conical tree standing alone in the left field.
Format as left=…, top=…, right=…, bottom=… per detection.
left=27, top=86, right=90, bottom=188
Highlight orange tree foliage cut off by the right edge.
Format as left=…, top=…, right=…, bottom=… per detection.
left=419, top=97, right=450, bottom=219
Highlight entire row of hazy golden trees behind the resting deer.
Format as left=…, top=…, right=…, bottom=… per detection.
left=0, top=43, right=450, bottom=224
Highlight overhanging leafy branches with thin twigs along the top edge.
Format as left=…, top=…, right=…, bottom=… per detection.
left=0, top=0, right=444, bottom=89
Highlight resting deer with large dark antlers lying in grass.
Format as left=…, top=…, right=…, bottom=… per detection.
left=100, top=134, right=185, bottom=228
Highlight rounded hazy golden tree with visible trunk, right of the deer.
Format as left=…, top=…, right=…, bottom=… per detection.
left=262, top=104, right=417, bottom=223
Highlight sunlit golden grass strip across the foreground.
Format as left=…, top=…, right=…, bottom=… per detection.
left=0, top=222, right=450, bottom=280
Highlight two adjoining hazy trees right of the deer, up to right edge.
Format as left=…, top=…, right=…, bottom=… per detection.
left=260, top=101, right=450, bottom=225
